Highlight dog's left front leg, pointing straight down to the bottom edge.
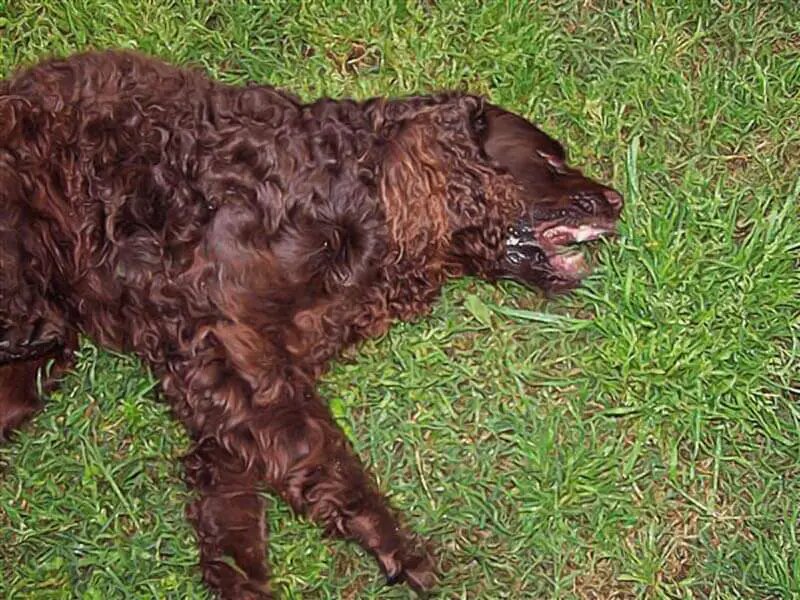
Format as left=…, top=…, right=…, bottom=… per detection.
left=162, top=348, right=273, bottom=600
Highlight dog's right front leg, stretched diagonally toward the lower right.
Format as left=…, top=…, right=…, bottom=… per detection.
left=247, top=389, right=435, bottom=591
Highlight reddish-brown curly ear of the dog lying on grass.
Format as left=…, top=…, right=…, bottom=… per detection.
left=381, top=95, right=522, bottom=268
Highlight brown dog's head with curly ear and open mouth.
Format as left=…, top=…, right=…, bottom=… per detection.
left=381, top=96, right=622, bottom=290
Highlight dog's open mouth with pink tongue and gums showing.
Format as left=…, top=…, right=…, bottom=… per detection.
left=505, top=219, right=616, bottom=289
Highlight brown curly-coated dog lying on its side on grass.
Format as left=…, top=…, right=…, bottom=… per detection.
left=0, top=52, right=622, bottom=598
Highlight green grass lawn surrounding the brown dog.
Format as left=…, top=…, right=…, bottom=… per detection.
left=0, top=0, right=800, bottom=599
